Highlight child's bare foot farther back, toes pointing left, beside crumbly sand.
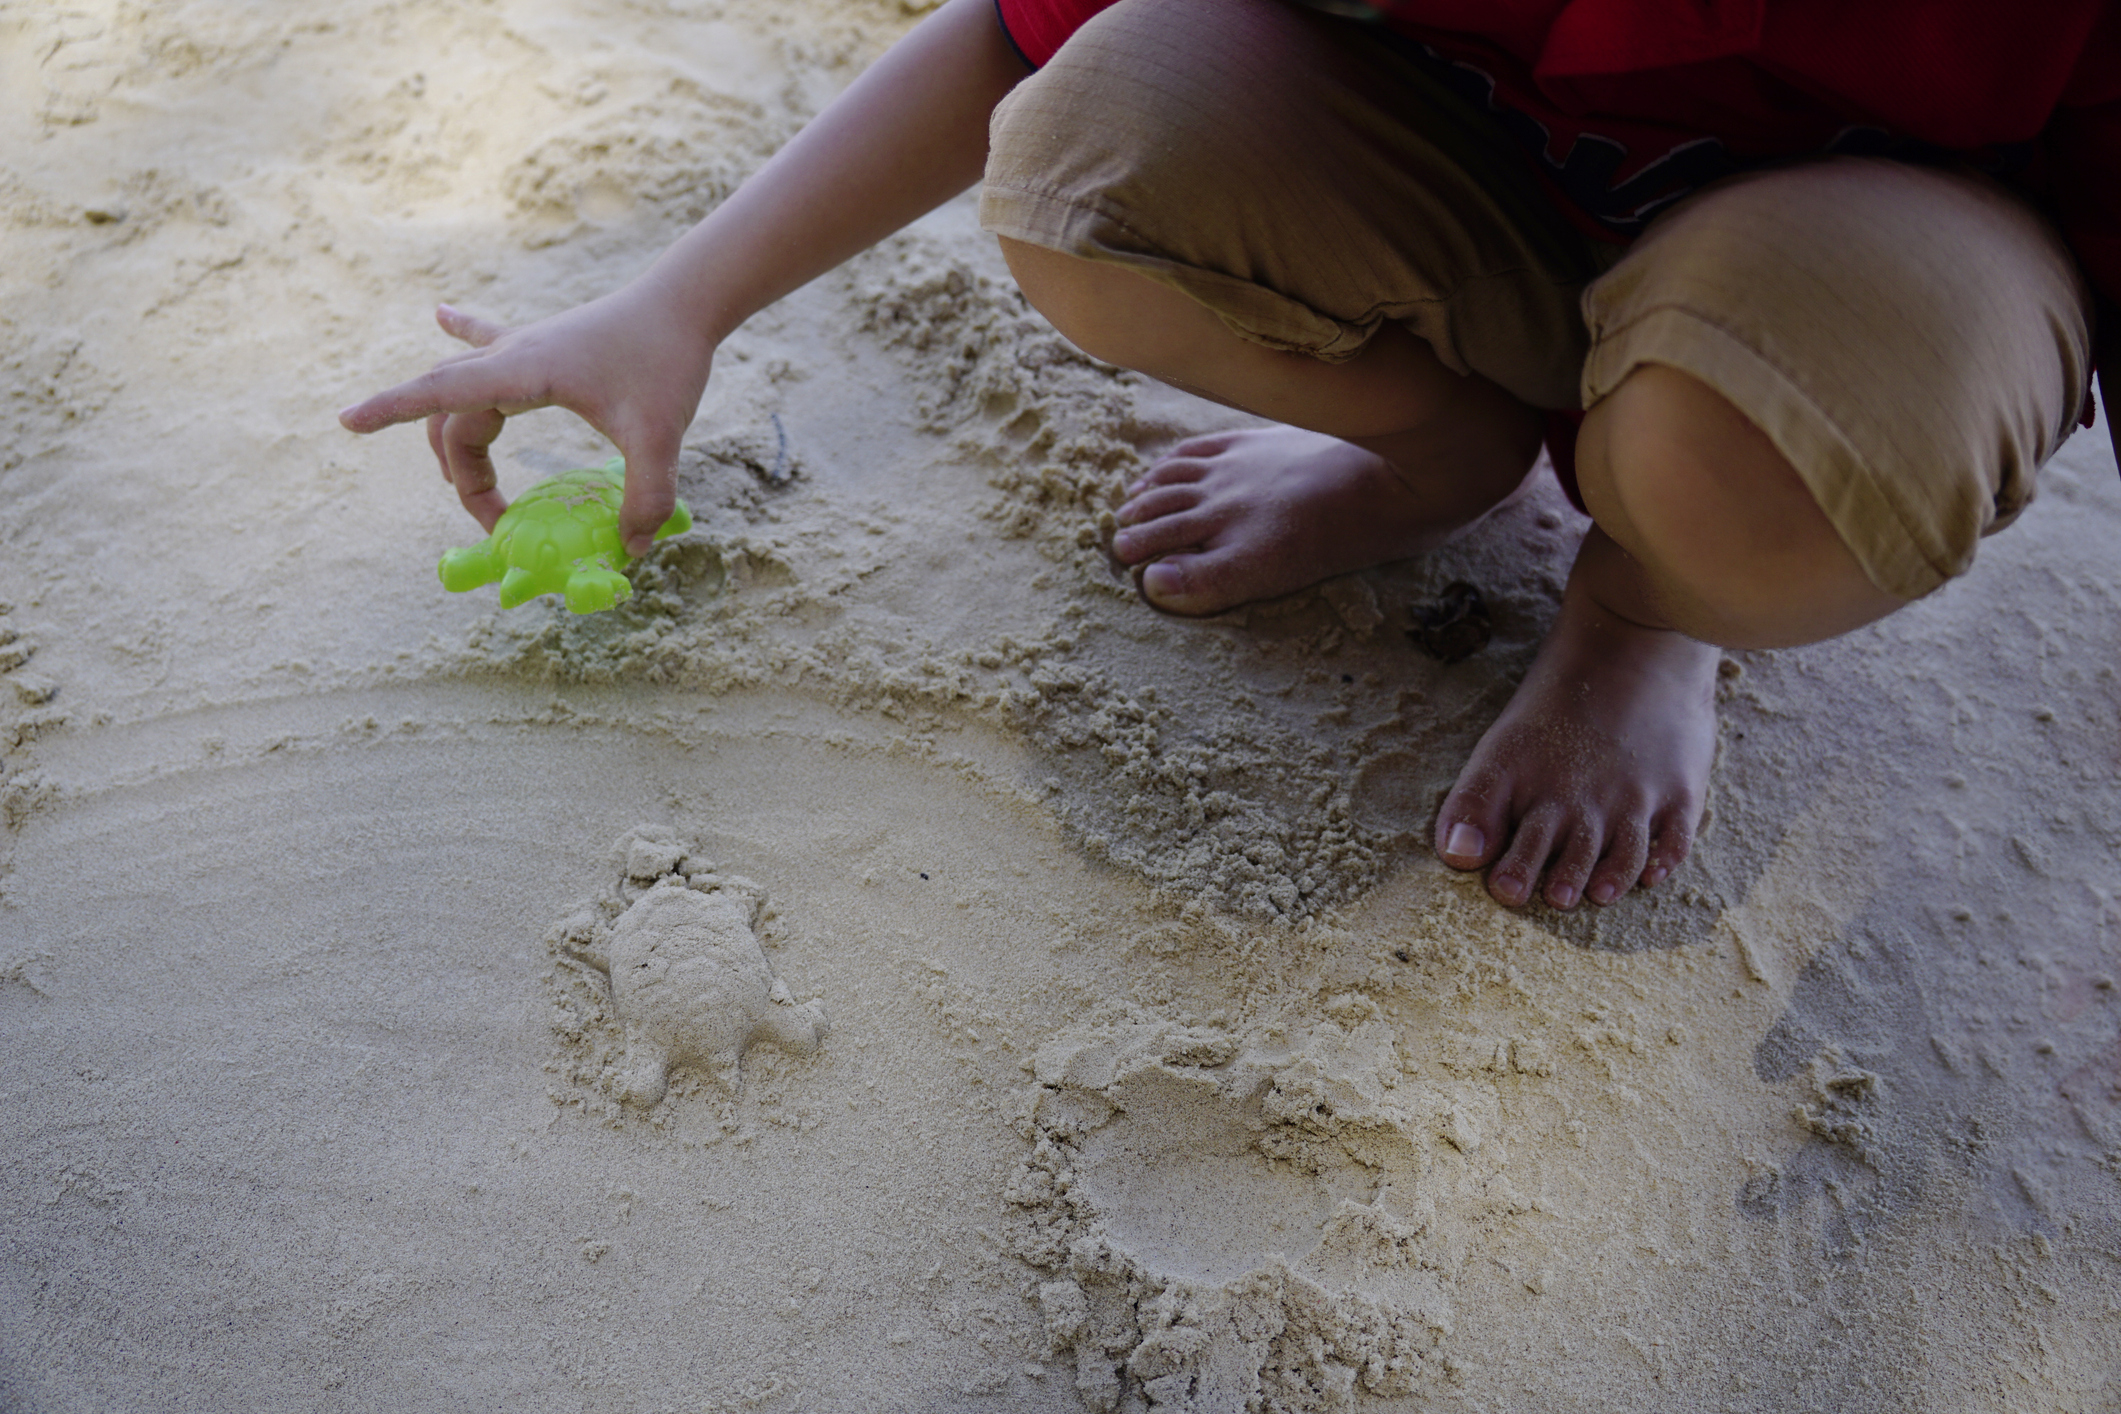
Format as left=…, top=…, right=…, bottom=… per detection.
left=1111, top=426, right=1529, bottom=615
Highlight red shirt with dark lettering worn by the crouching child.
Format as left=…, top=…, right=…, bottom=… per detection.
left=997, top=0, right=2121, bottom=303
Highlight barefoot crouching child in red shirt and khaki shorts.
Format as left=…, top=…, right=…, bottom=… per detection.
left=341, top=0, right=2121, bottom=907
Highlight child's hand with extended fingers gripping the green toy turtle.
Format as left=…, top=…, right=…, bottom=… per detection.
left=339, top=282, right=715, bottom=555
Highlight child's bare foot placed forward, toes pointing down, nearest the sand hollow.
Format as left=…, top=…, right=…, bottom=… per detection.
left=1436, top=581, right=1720, bottom=907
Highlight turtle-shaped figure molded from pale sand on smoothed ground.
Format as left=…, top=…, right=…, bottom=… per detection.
left=607, top=880, right=825, bottom=1104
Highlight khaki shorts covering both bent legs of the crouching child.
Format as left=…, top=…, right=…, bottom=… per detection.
left=980, top=0, right=2089, bottom=598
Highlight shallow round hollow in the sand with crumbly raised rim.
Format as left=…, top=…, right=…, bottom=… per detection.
left=1003, top=1022, right=1478, bottom=1414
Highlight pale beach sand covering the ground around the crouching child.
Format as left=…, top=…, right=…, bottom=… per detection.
left=0, top=0, right=2121, bottom=1414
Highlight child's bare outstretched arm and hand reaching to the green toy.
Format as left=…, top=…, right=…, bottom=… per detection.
left=339, top=0, right=1027, bottom=555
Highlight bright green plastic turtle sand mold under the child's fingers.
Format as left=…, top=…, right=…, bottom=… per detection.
left=435, top=456, right=691, bottom=613
